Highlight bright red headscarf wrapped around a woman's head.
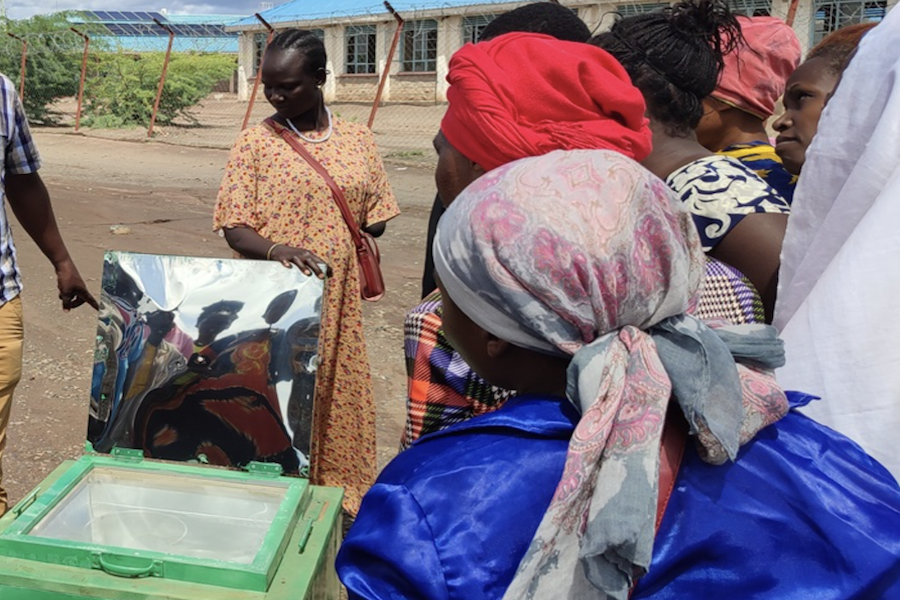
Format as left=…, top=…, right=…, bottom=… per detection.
left=441, top=33, right=651, bottom=171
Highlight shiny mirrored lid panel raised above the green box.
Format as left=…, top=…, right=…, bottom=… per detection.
left=87, top=252, right=324, bottom=473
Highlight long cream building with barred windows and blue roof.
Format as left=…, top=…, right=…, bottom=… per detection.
left=225, top=0, right=898, bottom=103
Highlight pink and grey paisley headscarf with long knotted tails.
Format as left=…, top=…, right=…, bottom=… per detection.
left=434, top=150, right=787, bottom=600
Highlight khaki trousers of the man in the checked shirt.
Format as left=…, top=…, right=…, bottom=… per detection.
left=0, top=296, right=24, bottom=515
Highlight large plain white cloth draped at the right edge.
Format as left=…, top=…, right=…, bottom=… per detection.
left=775, top=10, right=900, bottom=477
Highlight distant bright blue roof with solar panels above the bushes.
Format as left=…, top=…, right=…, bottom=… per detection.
left=69, top=10, right=243, bottom=54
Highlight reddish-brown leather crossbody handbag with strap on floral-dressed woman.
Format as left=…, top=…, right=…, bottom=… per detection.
left=266, top=118, right=384, bottom=302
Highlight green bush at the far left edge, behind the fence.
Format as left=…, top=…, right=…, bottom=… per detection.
left=0, top=13, right=92, bottom=124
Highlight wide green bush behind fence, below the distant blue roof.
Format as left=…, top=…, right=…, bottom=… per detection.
left=84, top=52, right=236, bottom=127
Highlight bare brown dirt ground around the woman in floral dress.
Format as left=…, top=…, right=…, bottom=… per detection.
left=3, top=131, right=434, bottom=502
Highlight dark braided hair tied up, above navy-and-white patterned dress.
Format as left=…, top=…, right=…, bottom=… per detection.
left=588, top=0, right=743, bottom=136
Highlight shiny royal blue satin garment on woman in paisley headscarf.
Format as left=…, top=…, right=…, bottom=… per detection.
left=337, top=394, right=900, bottom=600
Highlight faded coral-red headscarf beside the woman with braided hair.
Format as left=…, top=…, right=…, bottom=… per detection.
left=711, top=17, right=800, bottom=119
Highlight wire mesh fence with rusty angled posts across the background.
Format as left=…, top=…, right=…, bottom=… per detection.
left=0, top=0, right=889, bottom=164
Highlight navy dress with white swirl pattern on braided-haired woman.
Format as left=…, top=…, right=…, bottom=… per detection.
left=666, top=155, right=791, bottom=252
